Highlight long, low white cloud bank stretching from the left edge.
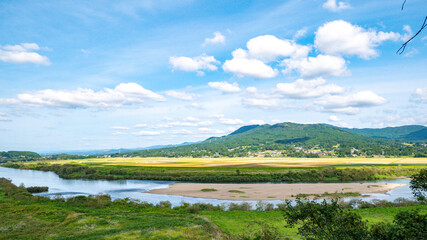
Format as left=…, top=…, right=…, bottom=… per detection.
left=0, top=83, right=165, bottom=109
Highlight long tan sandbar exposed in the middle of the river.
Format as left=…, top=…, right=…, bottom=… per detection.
left=149, top=183, right=406, bottom=200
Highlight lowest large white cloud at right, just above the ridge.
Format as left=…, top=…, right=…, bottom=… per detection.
left=315, top=91, right=387, bottom=114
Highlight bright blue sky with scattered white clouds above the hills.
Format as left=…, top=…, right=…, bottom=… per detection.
left=0, top=0, right=427, bottom=151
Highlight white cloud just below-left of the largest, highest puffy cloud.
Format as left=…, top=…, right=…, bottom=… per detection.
left=283, top=54, right=350, bottom=78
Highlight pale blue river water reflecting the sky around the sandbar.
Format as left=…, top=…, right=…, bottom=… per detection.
left=0, top=167, right=412, bottom=206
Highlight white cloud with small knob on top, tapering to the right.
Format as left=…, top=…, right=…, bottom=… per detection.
left=222, top=49, right=278, bottom=78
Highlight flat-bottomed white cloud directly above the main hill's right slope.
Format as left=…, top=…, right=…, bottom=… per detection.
left=276, top=78, right=344, bottom=99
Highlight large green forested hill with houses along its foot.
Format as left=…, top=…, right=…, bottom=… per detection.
left=124, top=122, right=427, bottom=157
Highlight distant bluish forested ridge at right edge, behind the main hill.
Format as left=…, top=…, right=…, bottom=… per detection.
left=340, top=125, right=427, bottom=141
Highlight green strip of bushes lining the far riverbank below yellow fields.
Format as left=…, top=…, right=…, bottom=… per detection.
left=4, top=163, right=420, bottom=183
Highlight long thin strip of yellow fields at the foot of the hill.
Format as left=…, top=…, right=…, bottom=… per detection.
left=43, top=157, right=427, bottom=167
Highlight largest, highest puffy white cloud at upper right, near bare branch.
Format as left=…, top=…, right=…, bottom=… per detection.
left=314, top=20, right=400, bottom=59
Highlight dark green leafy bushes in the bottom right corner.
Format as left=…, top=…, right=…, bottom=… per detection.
left=284, top=200, right=427, bottom=240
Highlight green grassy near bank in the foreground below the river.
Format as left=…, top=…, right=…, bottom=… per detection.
left=0, top=179, right=427, bottom=239
